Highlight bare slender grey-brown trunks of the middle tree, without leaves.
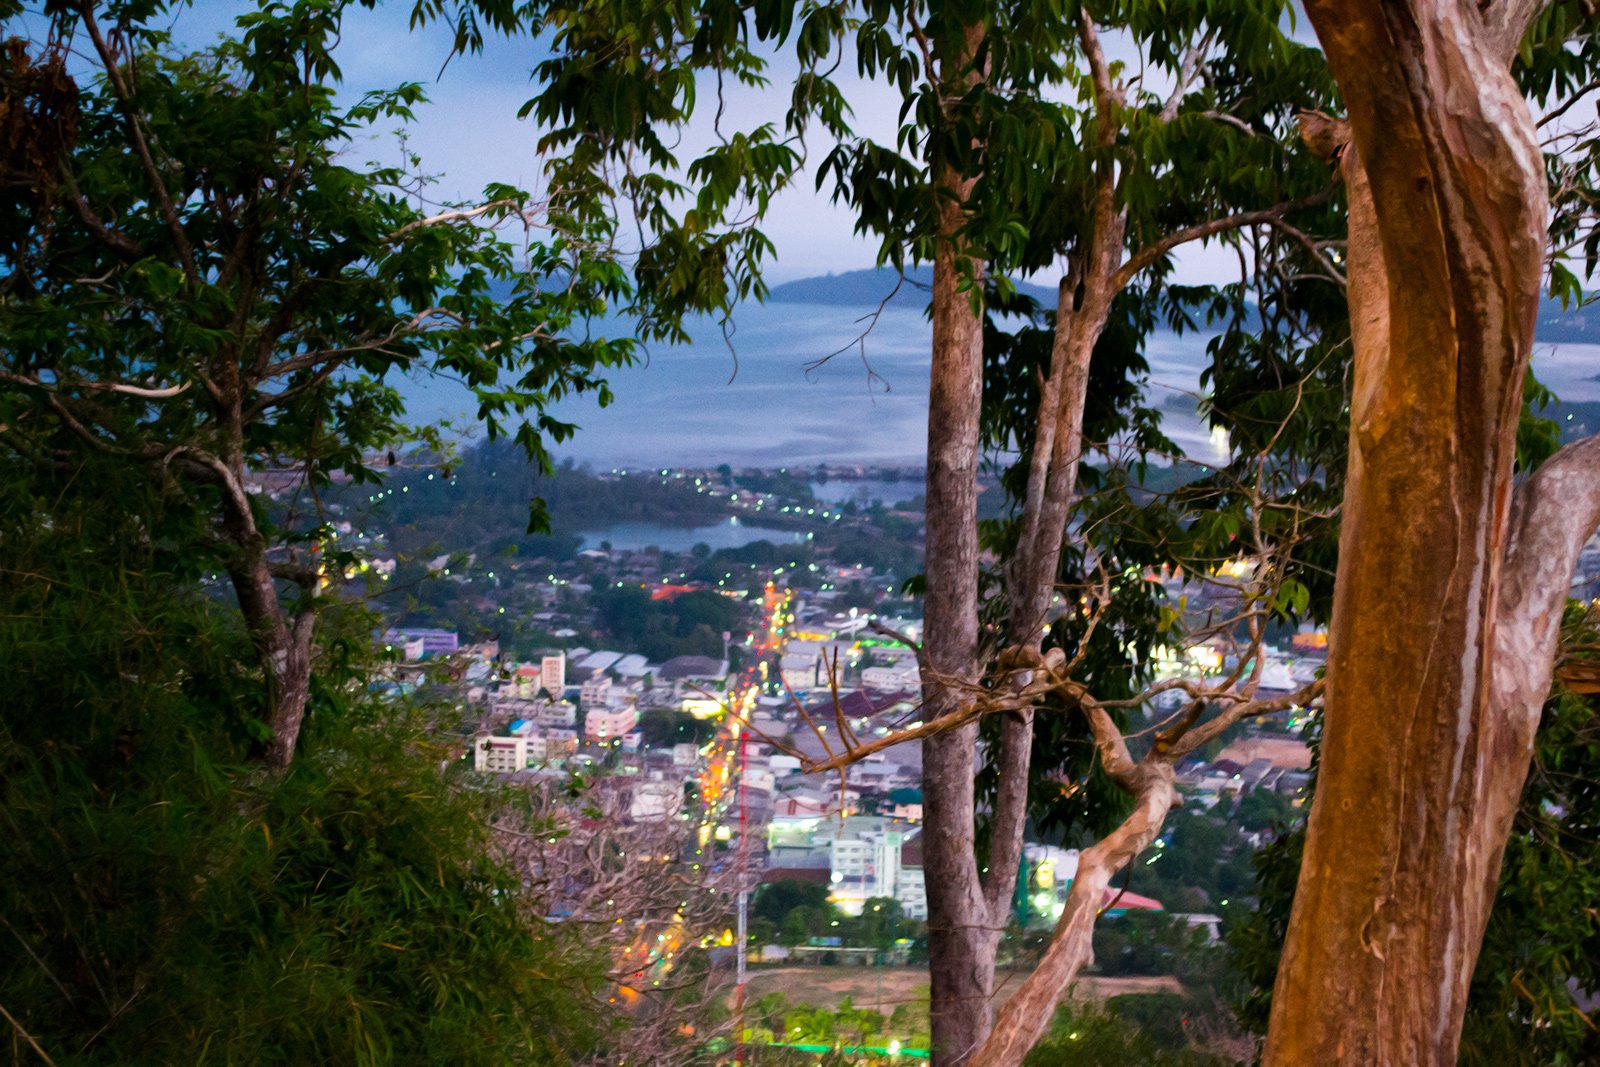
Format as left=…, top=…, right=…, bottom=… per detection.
left=923, top=11, right=1328, bottom=1064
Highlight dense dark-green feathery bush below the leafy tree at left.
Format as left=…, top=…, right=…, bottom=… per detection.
left=0, top=466, right=603, bottom=1064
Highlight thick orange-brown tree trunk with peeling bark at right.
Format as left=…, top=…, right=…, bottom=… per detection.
left=1264, top=0, right=1597, bottom=1067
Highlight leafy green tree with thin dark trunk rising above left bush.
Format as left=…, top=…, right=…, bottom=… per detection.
left=0, top=0, right=630, bottom=769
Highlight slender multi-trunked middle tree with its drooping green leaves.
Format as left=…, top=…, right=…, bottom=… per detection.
left=434, top=0, right=1336, bottom=1062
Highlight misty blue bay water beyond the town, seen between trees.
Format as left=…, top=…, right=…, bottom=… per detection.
left=396, top=301, right=1600, bottom=467
